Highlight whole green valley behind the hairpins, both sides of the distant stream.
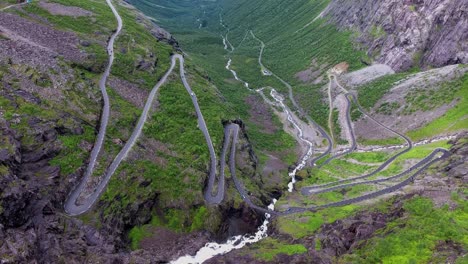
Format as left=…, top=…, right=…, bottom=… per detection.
left=132, top=0, right=366, bottom=131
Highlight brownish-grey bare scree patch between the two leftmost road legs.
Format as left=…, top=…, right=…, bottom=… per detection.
left=109, top=77, right=149, bottom=109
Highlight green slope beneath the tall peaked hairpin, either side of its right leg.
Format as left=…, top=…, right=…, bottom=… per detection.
left=102, top=71, right=229, bottom=211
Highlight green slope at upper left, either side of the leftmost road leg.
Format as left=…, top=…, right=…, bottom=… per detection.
left=19, top=0, right=172, bottom=89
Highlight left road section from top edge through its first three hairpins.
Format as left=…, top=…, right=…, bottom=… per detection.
left=64, top=0, right=229, bottom=215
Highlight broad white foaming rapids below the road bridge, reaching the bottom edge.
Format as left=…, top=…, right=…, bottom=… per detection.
left=171, top=199, right=276, bottom=264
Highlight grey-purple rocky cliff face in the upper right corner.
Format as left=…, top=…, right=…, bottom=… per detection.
left=321, top=0, right=468, bottom=71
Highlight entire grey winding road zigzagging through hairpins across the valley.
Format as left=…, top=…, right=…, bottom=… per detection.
left=64, top=0, right=449, bottom=221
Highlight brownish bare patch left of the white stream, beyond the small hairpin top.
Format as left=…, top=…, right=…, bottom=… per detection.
left=245, top=95, right=278, bottom=134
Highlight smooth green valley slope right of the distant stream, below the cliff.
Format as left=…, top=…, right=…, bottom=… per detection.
left=223, top=0, right=365, bottom=76
